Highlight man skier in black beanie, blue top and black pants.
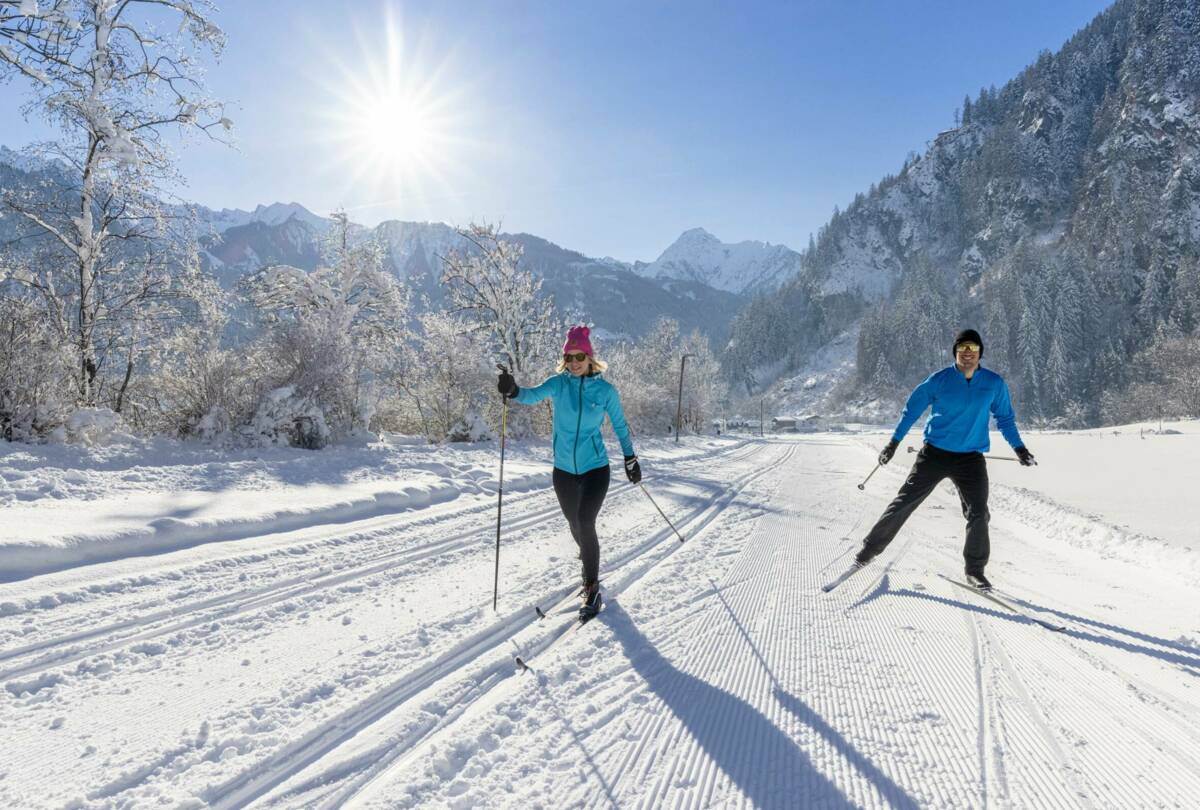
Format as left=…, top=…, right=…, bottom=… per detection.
left=854, top=329, right=1034, bottom=590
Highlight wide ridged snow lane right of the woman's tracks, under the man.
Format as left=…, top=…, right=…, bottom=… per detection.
left=340, top=439, right=1200, bottom=808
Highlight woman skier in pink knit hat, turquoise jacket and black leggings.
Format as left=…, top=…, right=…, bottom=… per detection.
left=497, top=325, right=642, bottom=622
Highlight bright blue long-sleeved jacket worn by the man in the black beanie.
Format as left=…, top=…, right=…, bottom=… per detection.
left=892, top=366, right=1025, bottom=452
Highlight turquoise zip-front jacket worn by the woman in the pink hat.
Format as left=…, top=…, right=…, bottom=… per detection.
left=514, top=371, right=634, bottom=475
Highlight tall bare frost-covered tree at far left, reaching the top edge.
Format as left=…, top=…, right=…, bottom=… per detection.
left=0, top=0, right=229, bottom=407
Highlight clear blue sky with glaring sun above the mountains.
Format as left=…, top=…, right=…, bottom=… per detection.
left=0, top=0, right=1106, bottom=260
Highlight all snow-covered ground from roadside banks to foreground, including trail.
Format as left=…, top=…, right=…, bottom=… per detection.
left=0, top=422, right=1200, bottom=808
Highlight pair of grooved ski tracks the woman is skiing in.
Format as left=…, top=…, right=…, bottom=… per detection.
left=205, top=444, right=796, bottom=808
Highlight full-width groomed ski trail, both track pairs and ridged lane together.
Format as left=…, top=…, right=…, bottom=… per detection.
left=0, top=436, right=1200, bottom=809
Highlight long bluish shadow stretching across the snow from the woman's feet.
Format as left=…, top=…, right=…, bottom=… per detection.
left=601, top=600, right=916, bottom=810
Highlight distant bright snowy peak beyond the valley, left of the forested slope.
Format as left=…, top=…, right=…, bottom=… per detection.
left=634, top=228, right=800, bottom=294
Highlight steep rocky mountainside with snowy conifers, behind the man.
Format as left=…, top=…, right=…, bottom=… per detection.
left=725, top=0, right=1200, bottom=432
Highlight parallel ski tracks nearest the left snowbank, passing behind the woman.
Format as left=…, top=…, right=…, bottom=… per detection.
left=0, top=443, right=766, bottom=682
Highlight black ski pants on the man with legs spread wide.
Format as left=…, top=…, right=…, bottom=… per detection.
left=858, top=444, right=991, bottom=574
